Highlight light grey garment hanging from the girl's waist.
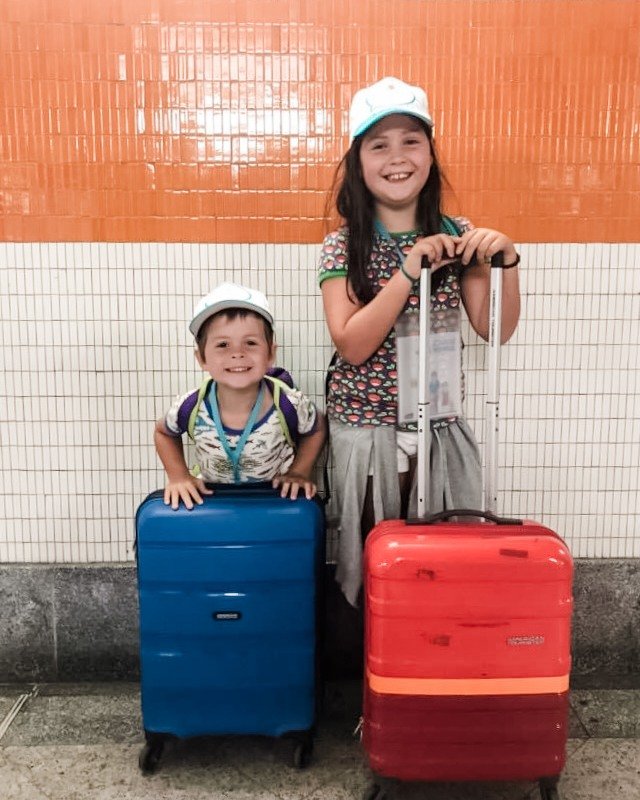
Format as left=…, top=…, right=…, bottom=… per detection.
left=327, top=418, right=482, bottom=606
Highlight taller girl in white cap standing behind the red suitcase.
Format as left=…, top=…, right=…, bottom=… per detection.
left=319, top=78, right=520, bottom=605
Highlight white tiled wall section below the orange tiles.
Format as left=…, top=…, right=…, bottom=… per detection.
left=0, top=243, right=640, bottom=563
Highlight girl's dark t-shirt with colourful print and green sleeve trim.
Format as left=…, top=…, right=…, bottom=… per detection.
left=318, top=217, right=473, bottom=429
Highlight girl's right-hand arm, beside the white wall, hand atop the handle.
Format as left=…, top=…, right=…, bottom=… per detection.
left=457, top=228, right=520, bottom=344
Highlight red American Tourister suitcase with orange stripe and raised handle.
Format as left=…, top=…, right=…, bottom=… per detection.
left=363, top=254, right=573, bottom=800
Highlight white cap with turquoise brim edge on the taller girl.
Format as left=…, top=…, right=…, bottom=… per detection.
left=349, top=78, right=433, bottom=142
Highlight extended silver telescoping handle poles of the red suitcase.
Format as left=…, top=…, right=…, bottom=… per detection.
left=417, top=251, right=504, bottom=521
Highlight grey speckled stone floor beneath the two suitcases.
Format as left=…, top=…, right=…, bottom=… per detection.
left=0, top=681, right=640, bottom=800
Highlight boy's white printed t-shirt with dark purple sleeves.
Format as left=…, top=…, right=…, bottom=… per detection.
left=164, top=384, right=316, bottom=483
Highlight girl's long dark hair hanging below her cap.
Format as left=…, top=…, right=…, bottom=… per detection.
left=334, top=125, right=449, bottom=303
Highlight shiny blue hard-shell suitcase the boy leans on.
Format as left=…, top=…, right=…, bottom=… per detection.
left=136, top=484, right=325, bottom=773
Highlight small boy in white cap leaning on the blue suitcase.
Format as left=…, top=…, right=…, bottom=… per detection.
left=154, top=283, right=325, bottom=509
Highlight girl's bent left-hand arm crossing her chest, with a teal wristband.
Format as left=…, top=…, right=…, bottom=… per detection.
left=322, top=234, right=458, bottom=364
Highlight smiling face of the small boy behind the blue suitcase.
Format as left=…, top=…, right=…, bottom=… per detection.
left=196, top=312, right=275, bottom=389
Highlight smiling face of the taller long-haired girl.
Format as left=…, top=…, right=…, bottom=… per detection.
left=360, top=114, right=433, bottom=220
